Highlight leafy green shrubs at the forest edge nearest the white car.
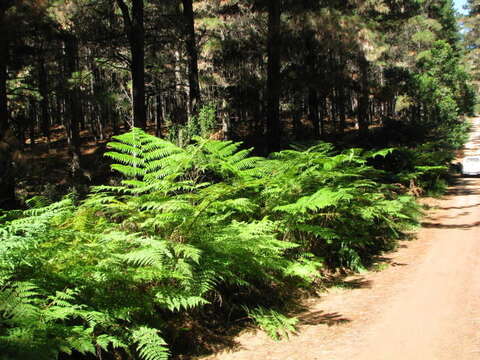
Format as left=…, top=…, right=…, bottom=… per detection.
left=378, top=40, right=475, bottom=169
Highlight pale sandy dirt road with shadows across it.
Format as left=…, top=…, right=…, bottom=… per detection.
left=204, top=118, right=480, bottom=360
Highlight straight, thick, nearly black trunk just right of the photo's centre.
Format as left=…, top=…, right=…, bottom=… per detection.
left=266, top=0, right=281, bottom=152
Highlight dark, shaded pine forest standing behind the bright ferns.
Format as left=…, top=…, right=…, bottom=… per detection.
left=0, top=0, right=478, bottom=206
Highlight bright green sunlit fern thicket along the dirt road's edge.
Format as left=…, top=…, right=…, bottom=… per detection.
left=0, top=129, right=438, bottom=360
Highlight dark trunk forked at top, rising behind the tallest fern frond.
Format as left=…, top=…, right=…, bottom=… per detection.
left=117, top=0, right=147, bottom=129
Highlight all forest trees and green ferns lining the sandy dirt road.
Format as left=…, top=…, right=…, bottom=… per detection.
left=0, top=0, right=478, bottom=360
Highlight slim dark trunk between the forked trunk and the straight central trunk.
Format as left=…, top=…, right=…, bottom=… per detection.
left=182, top=0, right=200, bottom=115
